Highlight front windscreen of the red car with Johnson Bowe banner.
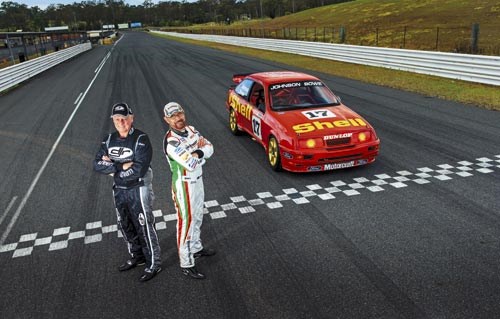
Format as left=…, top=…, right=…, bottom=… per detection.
left=269, top=81, right=340, bottom=111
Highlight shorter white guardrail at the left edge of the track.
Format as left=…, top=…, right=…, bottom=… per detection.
left=0, top=43, right=92, bottom=92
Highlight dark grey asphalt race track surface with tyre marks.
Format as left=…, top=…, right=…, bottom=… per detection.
left=0, top=33, right=500, bottom=319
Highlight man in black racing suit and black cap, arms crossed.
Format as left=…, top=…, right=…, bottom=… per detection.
left=94, top=103, right=161, bottom=281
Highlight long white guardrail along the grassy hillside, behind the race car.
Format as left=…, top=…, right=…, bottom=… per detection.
left=151, top=31, right=500, bottom=85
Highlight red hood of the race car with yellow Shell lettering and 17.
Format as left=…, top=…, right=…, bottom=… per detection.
left=275, top=104, right=370, bottom=137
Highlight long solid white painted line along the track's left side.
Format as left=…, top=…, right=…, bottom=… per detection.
left=0, top=49, right=110, bottom=246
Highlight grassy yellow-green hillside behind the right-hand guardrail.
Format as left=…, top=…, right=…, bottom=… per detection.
left=181, top=0, right=500, bottom=55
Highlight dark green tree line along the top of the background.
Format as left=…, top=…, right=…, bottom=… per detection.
left=0, top=0, right=351, bottom=32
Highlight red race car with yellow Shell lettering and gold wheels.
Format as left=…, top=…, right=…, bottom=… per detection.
left=226, top=71, right=380, bottom=172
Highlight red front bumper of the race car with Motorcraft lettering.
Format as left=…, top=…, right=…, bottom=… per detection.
left=280, top=140, right=380, bottom=172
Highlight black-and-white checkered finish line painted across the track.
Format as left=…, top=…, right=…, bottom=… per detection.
left=0, top=155, right=500, bottom=258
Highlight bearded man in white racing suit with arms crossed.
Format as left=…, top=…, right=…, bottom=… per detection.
left=163, top=102, right=215, bottom=279
